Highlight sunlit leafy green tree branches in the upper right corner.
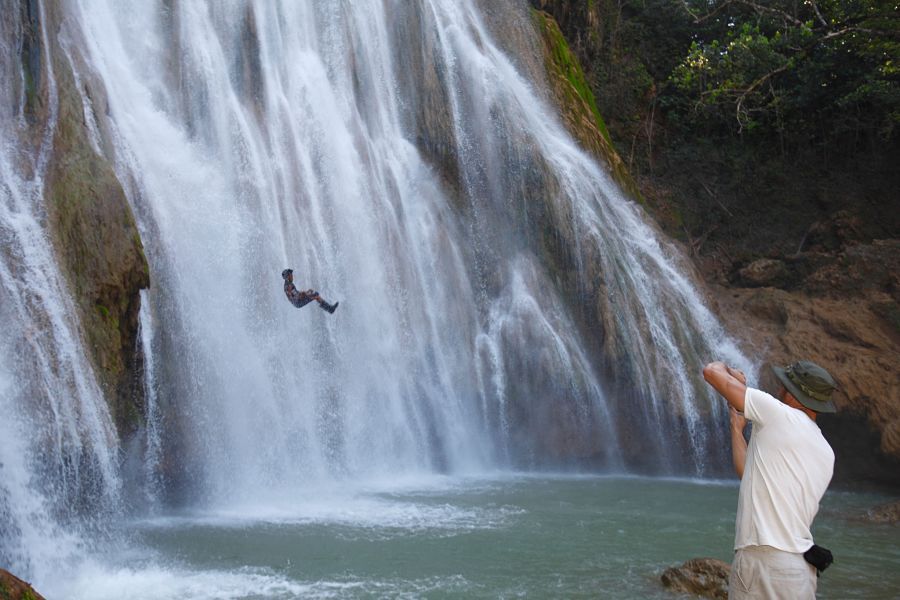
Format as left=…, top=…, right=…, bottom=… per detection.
left=665, top=0, right=900, bottom=146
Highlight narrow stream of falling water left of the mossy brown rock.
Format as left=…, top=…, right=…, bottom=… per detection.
left=0, top=1, right=121, bottom=576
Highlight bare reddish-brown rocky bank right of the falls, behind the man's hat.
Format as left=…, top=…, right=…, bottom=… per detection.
left=712, top=237, right=900, bottom=483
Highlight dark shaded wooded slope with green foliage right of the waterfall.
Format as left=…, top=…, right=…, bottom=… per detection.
left=533, top=0, right=900, bottom=273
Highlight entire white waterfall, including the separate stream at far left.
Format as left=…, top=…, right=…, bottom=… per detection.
left=0, top=0, right=750, bottom=572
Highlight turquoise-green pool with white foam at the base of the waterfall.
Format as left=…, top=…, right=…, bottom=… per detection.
left=51, top=476, right=900, bottom=599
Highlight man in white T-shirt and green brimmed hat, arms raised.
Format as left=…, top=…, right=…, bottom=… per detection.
left=703, top=360, right=837, bottom=600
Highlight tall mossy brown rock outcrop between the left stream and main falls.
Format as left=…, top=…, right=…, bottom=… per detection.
left=18, top=1, right=150, bottom=434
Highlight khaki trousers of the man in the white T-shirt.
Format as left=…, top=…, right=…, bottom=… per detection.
left=728, top=546, right=816, bottom=600
